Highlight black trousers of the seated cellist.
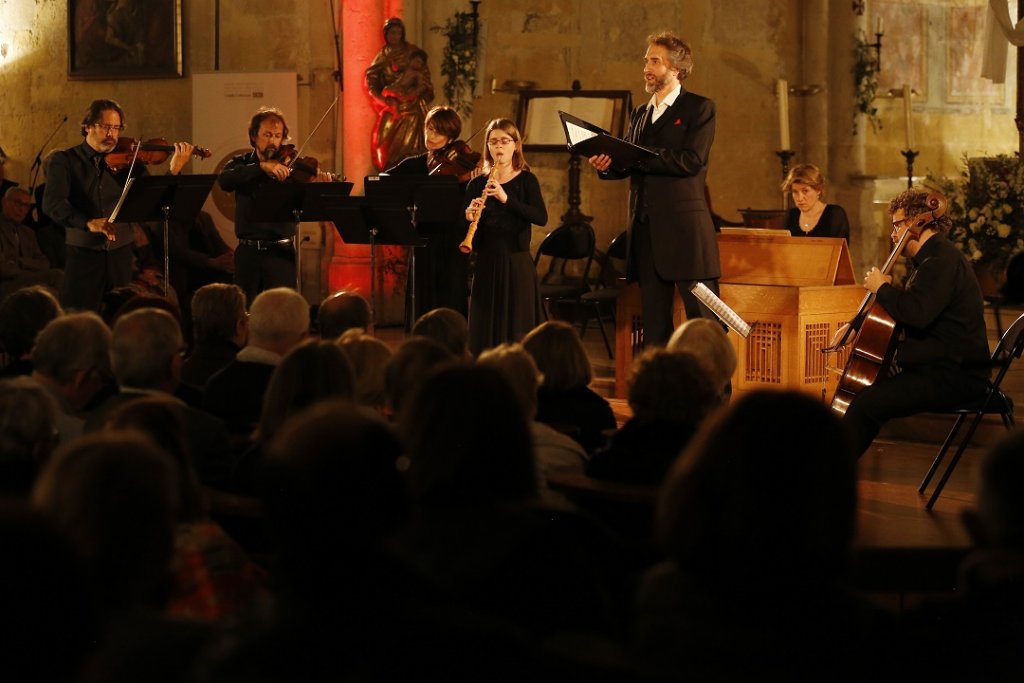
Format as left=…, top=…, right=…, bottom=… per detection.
left=843, top=366, right=988, bottom=456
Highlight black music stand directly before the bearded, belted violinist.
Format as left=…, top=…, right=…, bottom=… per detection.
left=247, top=182, right=352, bottom=292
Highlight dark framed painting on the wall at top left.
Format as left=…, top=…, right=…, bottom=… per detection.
left=68, top=0, right=182, bottom=80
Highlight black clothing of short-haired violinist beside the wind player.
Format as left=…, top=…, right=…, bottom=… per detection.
left=387, top=154, right=468, bottom=325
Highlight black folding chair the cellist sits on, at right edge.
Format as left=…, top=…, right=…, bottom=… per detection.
left=918, top=315, right=1024, bottom=510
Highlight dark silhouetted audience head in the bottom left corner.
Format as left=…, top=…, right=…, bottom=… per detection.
left=0, top=502, right=99, bottom=683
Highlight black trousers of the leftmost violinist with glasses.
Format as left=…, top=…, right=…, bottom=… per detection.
left=60, top=246, right=132, bottom=311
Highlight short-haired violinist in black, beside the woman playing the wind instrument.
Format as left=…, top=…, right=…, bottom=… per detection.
left=386, top=105, right=480, bottom=321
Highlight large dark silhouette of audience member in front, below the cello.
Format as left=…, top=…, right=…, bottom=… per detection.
left=634, top=391, right=892, bottom=681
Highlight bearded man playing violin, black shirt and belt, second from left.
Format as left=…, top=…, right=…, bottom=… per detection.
left=217, top=106, right=333, bottom=302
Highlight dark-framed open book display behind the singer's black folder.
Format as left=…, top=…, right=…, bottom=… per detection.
left=516, top=90, right=632, bottom=153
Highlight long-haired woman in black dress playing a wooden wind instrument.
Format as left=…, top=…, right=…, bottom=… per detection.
left=466, top=119, right=548, bottom=355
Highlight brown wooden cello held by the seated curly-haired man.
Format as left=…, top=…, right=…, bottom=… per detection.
left=821, top=193, right=948, bottom=417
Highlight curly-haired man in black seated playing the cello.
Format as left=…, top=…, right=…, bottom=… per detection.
left=844, top=187, right=989, bottom=455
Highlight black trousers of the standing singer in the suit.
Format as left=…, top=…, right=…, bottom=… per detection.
left=632, top=220, right=719, bottom=348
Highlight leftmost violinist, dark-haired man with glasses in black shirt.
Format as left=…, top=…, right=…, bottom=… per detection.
left=43, top=99, right=195, bottom=310
